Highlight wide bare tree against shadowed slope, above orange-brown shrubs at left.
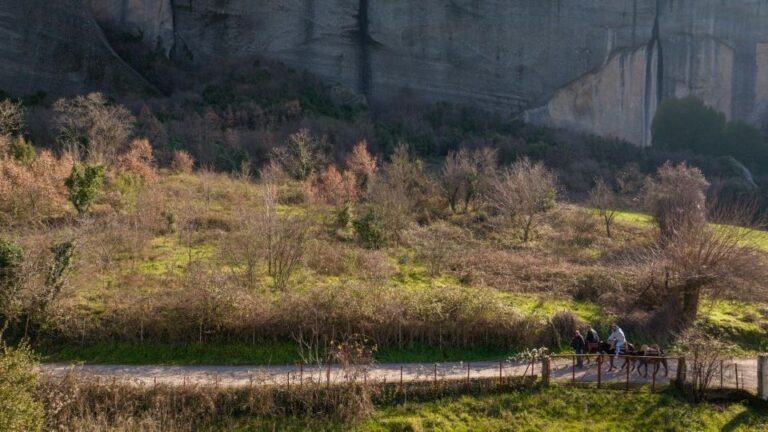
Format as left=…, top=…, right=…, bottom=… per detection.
left=53, top=93, right=136, bottom=164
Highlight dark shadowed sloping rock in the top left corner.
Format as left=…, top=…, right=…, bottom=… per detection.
left=0, top=0, right=151, bottom=95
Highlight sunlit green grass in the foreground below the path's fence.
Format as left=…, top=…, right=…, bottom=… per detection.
left=220, top=387, right=768, bottom=432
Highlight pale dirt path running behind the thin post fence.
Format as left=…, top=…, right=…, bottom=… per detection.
left=42, top=359, right=757, bottom=391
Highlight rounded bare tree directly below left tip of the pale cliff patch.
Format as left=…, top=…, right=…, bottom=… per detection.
left=488, top=158, right=557, bottom=243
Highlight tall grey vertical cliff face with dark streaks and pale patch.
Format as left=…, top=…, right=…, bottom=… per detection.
left=0, top=0, right=768, bottom=144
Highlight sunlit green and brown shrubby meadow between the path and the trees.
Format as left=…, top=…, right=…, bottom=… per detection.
left=10, top=172, right=768, bottom=364
